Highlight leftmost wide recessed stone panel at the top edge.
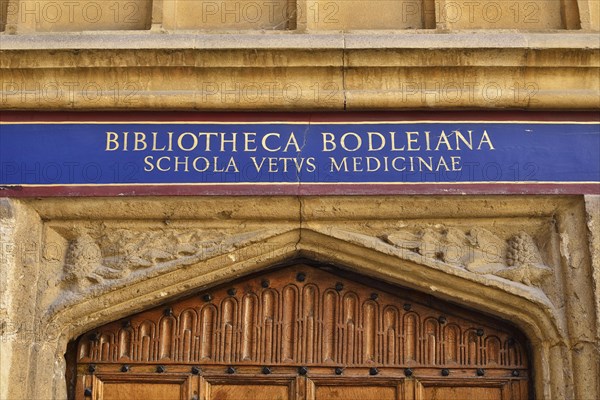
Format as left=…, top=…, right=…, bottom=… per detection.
left=7, top=0, right=152, bottom=32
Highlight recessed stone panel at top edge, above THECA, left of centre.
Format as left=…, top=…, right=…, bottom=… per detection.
left=163, top=0, right=296, bottom=30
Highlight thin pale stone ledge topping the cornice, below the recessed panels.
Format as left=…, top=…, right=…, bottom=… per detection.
left=0, top=30, right=600, bottom=50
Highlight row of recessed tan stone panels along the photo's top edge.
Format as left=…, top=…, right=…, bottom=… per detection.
left=0, top=0, right=599, bottom=33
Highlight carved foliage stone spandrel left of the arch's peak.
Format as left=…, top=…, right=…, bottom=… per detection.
left=55, top=228, right=292, bottom=306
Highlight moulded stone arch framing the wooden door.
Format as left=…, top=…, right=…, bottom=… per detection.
left=43, top=229, right=568, bottom=398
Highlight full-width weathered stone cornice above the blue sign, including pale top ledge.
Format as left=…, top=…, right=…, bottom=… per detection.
left=0, top=33, right=600, bottom=111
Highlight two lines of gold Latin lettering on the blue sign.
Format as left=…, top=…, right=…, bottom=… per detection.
left=104, top=125, right=496, bottom=174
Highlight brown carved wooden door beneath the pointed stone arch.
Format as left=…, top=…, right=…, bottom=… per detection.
left=74, top=265, right=530, bottom=400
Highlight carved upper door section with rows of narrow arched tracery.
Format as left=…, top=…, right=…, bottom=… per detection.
left=77, top=265, right=528, bottom=374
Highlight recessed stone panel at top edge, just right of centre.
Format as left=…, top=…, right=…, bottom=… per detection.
left=299, top=0, right=425, bottom=30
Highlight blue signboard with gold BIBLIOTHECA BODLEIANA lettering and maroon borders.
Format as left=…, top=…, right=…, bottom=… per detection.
left=0, top=117, right=600, bottom=192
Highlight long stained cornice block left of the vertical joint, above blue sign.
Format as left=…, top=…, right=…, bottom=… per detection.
left=3, top=53, right=343, bottom=110
